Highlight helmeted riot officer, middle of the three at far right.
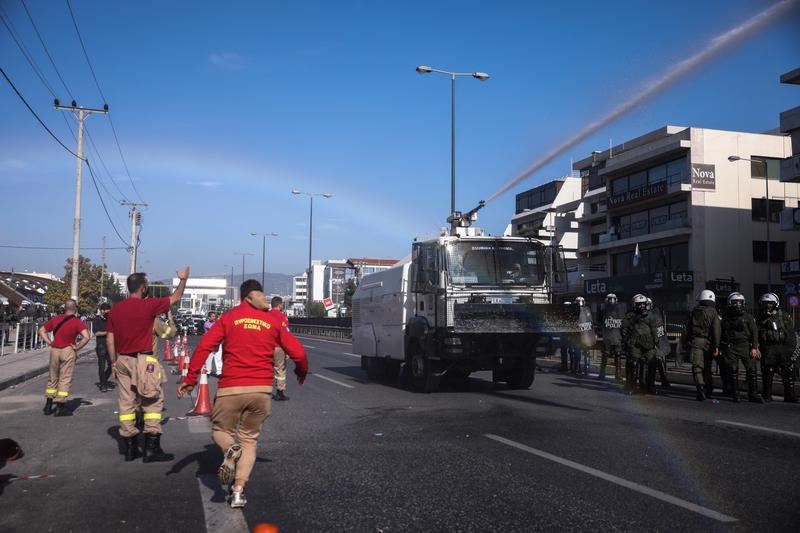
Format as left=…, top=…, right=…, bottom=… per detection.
left=720, top=292, right=764, bottom=403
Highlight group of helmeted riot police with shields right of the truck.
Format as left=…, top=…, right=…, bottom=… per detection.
left=561, top=290, right=800, bottom=403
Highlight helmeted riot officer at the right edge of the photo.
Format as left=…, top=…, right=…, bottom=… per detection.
left=758, top=292, right=797, bottom=403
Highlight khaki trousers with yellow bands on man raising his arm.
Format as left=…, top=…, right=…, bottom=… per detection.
left=114, top=354, right=164, bottom=437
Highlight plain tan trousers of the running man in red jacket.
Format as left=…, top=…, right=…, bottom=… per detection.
left=211, top=392, right=272, bottom=487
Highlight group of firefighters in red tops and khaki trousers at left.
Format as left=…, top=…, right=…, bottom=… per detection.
left=39, top=267, right=308, bottom=508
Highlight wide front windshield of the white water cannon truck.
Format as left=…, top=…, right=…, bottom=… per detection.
left=446, top=240, right=544, bottom=286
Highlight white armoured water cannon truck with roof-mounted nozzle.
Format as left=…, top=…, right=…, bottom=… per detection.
left=352, top=201, right=578, bottom=392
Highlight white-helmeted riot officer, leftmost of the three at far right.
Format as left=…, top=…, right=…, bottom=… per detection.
left=686, top=290, right=721, bottom=402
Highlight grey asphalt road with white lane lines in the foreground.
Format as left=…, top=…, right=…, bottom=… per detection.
left=0, top=339, right=800, bottom=533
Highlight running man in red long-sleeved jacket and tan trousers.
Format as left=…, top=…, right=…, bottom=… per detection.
left=178, top=279, right=308, bottom=507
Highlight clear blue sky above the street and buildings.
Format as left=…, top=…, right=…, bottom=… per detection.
left=0, top=0, right=800, bottom=277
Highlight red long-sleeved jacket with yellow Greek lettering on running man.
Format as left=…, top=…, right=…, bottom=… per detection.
left=183, top=300, right=308, bottom=388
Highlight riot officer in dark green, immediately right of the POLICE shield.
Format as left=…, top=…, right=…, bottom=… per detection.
left=622, top=294, right=658, bottom=394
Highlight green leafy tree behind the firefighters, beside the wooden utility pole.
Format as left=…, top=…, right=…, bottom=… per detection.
left=44, top=256, right=123, bottom=313
